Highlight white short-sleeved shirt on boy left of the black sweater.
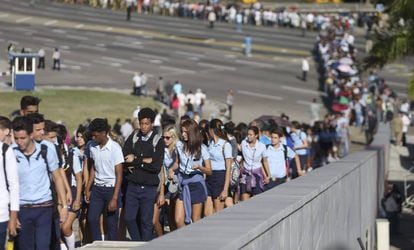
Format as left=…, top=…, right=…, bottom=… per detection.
left=90, top=138, right=124, bottom=187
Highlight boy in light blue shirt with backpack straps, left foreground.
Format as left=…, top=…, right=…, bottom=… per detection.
left=12, top=117, right=68, bottom=249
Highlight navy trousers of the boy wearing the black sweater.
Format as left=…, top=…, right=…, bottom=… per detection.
left=125, top=184, right=157, bottom=241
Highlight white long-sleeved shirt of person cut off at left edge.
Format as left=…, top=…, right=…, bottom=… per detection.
left=0, top=142, right=19, bottom=222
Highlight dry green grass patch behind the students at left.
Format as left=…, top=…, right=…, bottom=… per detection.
left=0, top=88, right=160, bottom=133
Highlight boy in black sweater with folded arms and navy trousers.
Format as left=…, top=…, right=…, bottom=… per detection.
left=123, top=108, right=165, bottom=241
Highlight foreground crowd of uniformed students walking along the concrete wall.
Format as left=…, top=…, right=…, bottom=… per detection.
left=0, top=89, right=360, bottom=249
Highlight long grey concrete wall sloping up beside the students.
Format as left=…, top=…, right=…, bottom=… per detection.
left=137, top=124, right=390, bottom=250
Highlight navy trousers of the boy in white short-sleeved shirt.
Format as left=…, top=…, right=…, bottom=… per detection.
left=88, top=186, right=121, bottom=241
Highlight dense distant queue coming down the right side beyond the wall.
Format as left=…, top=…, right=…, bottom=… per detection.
left=314, top=14, right=411, bottom=148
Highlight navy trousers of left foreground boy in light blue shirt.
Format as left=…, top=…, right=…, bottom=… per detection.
left=17, top=207, right=53, bottom=250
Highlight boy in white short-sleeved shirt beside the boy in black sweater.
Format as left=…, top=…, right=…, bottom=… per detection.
left=85, top=118, right=124, bottom=241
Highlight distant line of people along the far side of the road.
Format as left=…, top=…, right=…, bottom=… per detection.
left=49, top=0, right=380, bottom=34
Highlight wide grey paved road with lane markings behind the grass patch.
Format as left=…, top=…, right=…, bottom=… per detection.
left=0, top=0, right=408, bottom=122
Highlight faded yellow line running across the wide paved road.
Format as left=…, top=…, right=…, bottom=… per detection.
left=0, top=11, right=310, bottom=56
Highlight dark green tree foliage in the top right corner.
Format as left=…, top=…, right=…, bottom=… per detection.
left=365, top=0, right=414, bottom=101
